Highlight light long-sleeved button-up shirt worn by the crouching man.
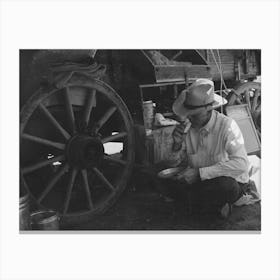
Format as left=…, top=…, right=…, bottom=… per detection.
left=172, top=111, right=249, bottom=183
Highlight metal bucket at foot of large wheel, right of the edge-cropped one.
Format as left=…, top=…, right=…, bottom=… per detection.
left=31, top=210, right=59, bottom=230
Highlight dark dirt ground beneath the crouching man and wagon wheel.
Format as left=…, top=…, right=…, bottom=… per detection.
left=63, top=176, right=261, bottom=231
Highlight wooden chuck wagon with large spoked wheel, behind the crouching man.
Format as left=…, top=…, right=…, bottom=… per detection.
left=20, top=50, right=260, bottom=223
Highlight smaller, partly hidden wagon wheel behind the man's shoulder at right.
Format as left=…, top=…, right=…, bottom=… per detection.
left=228, top=82, right=261, bottom=136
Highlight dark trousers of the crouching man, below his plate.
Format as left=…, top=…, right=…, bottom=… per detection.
left=156, top=176, right=243, bottom=212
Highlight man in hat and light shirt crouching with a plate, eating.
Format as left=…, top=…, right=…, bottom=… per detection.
left=158, top=79, right=249, bottom=217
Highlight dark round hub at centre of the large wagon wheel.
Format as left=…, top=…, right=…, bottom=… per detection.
left=66, top=135, right=104, bottom=169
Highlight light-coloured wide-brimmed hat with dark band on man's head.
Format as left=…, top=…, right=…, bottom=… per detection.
left=172, top=79, right=227, bottom=118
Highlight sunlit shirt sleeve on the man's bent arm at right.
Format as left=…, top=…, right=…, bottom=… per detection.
left=199, top=120, right=249, bottom=180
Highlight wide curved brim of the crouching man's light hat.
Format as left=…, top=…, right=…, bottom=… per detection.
left=172, top=91, right=227, bottom=118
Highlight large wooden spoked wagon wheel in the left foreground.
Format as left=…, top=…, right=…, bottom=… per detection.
left=20, top=76, right=134, bottom=224
